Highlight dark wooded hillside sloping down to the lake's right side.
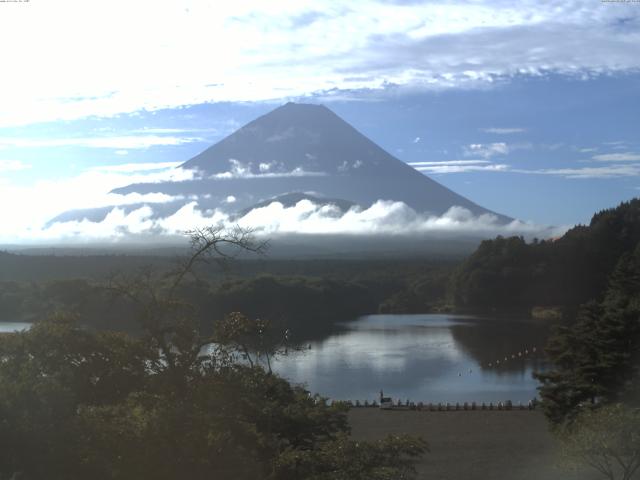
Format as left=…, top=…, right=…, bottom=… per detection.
left=451, top=198, right=640, bottom=309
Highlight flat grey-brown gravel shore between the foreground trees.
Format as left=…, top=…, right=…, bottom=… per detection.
left=349, top=408, right=599, bottom=480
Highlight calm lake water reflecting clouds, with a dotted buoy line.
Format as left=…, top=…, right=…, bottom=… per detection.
left=274, top=314, right=548, bottom=403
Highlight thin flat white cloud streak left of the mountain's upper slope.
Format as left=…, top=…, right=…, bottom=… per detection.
left=0, top=135, right=203, bottom=148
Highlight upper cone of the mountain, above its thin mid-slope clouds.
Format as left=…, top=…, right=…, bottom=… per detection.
left=182, top=103, right=420, bottom=176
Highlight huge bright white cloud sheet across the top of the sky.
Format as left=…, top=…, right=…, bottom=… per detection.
left=0, top=0, right=640, bottom=126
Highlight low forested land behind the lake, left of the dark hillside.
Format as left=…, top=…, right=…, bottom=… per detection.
left=0, top=253, right=455, bottom=340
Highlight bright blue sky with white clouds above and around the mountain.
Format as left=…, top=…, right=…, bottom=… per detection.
left=0, top=0, right=640, bottom=241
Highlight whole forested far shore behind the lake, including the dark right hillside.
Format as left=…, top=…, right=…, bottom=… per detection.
left=7, top=199, right=640, bottom=330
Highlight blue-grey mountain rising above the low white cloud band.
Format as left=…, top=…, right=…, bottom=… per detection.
left=53, top=103, right=511, bottom=227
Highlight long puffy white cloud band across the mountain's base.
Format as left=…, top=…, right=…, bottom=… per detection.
left=25, top=200, right=565, bottom=246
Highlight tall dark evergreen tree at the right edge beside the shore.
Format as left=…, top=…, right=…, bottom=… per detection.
left=536, top=246, right=640, bottom=425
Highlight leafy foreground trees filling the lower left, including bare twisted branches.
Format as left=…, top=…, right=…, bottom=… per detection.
left=0, top=229, right=425, bottom=480
